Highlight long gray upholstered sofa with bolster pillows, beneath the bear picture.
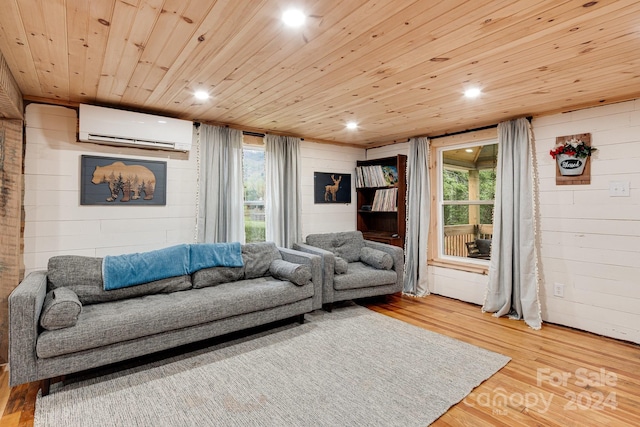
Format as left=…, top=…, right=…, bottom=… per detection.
left=9, top=243, right=322, bottom=394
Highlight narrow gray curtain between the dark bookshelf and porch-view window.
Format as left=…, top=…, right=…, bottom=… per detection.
left=403, top=138, right=431, bottom=296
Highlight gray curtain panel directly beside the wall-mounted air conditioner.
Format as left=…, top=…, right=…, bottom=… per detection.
left=197, top=124, right=245, bottom=243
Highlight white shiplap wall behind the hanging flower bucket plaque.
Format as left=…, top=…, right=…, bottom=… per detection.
left=533, top=100, right=640, bottom=343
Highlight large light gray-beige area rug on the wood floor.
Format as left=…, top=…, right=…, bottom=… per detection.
left=35, top=305, right=509, bottom=427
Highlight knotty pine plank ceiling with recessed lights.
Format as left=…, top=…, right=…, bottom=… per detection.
left=0, top=0, right=640, bottom=146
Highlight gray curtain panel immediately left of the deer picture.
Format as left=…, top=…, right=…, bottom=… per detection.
left=265, top=135, right=302, bottom=248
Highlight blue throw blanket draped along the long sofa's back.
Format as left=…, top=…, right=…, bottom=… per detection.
left=102, top=242, right=243, bottom=291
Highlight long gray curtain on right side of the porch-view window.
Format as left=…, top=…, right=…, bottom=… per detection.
left=482, top=118, right=542, bottom=329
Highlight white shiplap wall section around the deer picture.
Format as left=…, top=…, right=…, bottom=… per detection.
left=300, top=140, right=365, bottom=239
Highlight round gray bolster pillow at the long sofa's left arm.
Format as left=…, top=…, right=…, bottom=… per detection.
left=40, top=288, right=82, bottom=331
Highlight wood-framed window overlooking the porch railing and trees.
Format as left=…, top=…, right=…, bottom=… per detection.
left=438, top=140, right=498, bottom=262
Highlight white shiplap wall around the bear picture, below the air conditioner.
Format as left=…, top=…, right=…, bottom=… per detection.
left=24, top=104, right=197, bottom=273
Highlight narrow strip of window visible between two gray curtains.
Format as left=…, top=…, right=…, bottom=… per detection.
left=242, top=145, right=265, bottom=243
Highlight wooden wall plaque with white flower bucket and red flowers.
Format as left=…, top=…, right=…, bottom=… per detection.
left=549, top=133, right=596, bottom=185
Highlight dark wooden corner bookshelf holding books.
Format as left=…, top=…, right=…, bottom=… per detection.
left=356, top=154, right=407, bottom=247
